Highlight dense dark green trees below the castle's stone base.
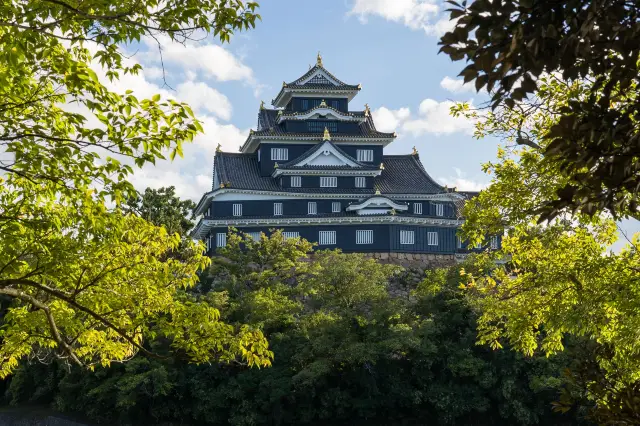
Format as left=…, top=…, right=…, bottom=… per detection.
left=7, top=232, right=586, bottom=425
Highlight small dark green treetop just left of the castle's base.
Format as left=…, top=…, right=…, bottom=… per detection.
left=123, top=186, right=196, bottom=236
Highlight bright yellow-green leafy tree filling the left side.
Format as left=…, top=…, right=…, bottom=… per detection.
left=0, top=0, right=272, bottom=377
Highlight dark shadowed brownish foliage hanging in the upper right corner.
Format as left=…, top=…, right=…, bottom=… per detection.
left=440, top=0, right=640, bottom=220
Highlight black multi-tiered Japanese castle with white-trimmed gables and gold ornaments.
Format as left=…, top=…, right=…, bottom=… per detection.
left=193, top=54, right=500, bottom=254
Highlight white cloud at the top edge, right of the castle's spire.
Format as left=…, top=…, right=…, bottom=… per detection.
left=347, top=0, right=454, bottom=36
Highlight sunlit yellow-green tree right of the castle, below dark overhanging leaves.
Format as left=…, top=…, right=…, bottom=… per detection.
left=454, top=76, right=640, bottom=413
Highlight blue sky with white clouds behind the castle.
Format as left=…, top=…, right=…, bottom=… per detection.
left=97, top=0, right=640, bottom=250
